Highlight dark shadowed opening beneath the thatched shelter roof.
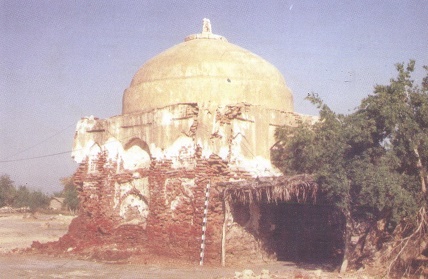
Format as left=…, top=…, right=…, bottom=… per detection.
left=259, top=203, right=345, bottom=263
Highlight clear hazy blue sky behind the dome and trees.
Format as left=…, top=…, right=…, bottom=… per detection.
left=0, top=0, right=428, bottom=192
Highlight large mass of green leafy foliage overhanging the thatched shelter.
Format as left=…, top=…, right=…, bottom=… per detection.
left=272, top=61, right=428, bottom=223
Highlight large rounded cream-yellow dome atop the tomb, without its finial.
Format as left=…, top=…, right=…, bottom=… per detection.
left=122, top=20, right=293, bottom=114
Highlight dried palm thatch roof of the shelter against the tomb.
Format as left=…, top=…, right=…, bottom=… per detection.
left=219, top=174, right=318, bottom=206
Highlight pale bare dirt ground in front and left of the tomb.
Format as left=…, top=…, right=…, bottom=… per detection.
left=0, top=214, right=377, bottom=279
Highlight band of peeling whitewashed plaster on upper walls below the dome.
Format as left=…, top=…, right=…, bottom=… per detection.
left=72, top=102, right=314, bottom=179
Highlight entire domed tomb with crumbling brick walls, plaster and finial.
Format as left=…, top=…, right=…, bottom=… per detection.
left=67, top=20, right=322, bottom=262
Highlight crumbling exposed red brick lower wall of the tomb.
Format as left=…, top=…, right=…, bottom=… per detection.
left=60, top=152, right=264, bottom=264
